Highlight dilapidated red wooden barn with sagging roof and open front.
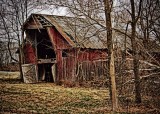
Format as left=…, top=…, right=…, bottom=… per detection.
left=22, top=14, right=107, bottom=84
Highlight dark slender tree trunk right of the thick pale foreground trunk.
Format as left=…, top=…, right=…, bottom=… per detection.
left=130, top=0, right=141, bottom=103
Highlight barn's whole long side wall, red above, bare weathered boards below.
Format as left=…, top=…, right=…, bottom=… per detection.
left=61, top=49, right=107, bottom=84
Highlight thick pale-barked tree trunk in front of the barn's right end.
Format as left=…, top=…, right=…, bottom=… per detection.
left=104, top=0, right=118, bottom=111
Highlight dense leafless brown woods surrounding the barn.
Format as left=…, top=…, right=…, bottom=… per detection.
left=0, top=0, right=160, bottom=112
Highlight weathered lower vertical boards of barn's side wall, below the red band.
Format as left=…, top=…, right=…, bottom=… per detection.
left=61, top=57, right=107, bottom=84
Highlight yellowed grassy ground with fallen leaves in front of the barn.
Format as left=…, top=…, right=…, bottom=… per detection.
left=0, top=72, right=160, bottom=114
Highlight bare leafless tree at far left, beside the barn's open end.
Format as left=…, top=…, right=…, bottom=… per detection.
left=0, top=0, right=39, bottom=80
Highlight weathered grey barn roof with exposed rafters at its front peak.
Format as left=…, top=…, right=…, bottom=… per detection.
left=23, top=14, right=107, bottom=49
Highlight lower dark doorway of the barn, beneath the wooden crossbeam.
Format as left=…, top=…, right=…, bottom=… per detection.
left=38, top=63, right=56, bottom=82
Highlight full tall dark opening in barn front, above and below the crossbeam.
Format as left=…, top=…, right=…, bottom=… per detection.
left=36, top=29, right=56, bottom=82
